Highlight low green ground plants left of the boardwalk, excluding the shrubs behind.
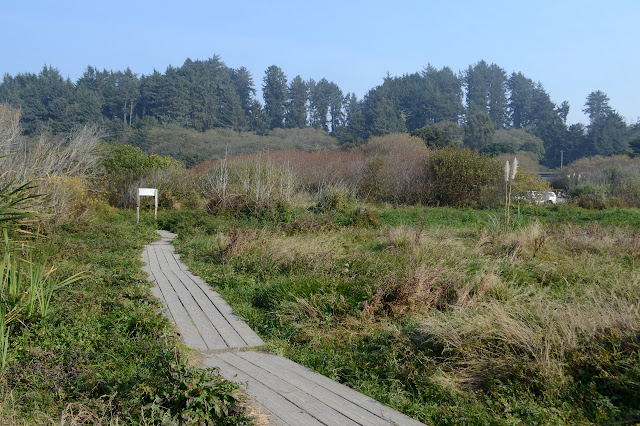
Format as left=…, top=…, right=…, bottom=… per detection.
left=0, top=209, right=249, bottom=424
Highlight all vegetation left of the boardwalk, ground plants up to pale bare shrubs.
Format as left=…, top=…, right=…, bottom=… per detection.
left=0, top=110, right=250, bottom=424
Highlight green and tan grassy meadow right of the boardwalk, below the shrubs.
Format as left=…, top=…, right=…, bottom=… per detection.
left=160, top=206, right=640, bottom=424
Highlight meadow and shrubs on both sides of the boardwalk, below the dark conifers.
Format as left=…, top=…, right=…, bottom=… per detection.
left=0, top=106, right=640, bottom=424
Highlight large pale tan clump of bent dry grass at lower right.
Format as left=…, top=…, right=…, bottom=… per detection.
left=412, top=289, right=640, bottom=385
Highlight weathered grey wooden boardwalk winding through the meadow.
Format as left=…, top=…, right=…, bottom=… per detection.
left=142, top=231, right=422, bottom=426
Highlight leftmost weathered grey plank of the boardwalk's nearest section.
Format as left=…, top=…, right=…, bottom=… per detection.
left=204, top=355, right=322, bottom=426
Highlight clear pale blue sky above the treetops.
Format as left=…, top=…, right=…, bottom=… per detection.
left=0, top=0, right=640, bottom=123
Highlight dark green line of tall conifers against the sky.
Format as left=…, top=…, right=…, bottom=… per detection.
left=0, top=56, right=640, bottom=166
